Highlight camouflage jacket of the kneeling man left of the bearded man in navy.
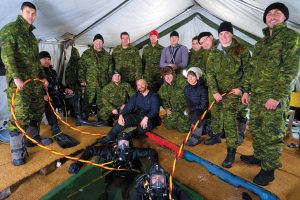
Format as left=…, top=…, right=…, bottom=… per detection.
left=102, top=81, right=135, bottom=110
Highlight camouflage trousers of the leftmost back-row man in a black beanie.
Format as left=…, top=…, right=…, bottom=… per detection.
left=82, top=87, right=102, bottom=117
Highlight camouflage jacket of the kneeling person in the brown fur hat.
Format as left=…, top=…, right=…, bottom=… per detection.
left=158, top=74, right=187, bottom=112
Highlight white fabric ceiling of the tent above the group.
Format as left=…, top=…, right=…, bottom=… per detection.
left=0, top=0, right=300, bottom=47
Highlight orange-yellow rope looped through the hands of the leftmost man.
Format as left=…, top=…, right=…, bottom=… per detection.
left=10, top=78, right=128, bottom=171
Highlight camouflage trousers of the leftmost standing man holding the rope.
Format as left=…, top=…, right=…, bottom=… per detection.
left=6, top=82, right=44, bottom=132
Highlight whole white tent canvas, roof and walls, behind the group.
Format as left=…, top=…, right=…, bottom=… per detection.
left=0, top=0, right=300, bottom=120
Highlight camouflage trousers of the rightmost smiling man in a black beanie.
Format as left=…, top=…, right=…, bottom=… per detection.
left=249, top=95, right=286, bottom=170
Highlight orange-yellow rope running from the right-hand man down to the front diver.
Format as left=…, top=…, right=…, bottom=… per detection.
left=169, top=90, right=232, bottom=199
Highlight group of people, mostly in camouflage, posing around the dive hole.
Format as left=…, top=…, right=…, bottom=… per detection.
left=0, top=2, right=299, bottom=193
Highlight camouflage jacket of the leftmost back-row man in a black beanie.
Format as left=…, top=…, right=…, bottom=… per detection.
left=78, top=47, right=110, bottom=88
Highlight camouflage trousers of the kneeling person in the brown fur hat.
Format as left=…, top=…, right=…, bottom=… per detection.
left=162, top=112, right=191, bottom=133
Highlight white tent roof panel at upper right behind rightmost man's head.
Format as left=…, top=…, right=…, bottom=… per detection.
left=196, top=0, right=300, bottom=37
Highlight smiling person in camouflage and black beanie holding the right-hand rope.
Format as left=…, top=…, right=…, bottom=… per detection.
left=207, top=22, right=250, bottom=168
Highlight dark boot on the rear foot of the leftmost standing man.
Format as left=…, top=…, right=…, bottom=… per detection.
left=25, top=125, right=53, bottom=147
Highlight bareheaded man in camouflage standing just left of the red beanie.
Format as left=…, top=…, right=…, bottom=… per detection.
left=112, top=32, right=142, bottom=88
